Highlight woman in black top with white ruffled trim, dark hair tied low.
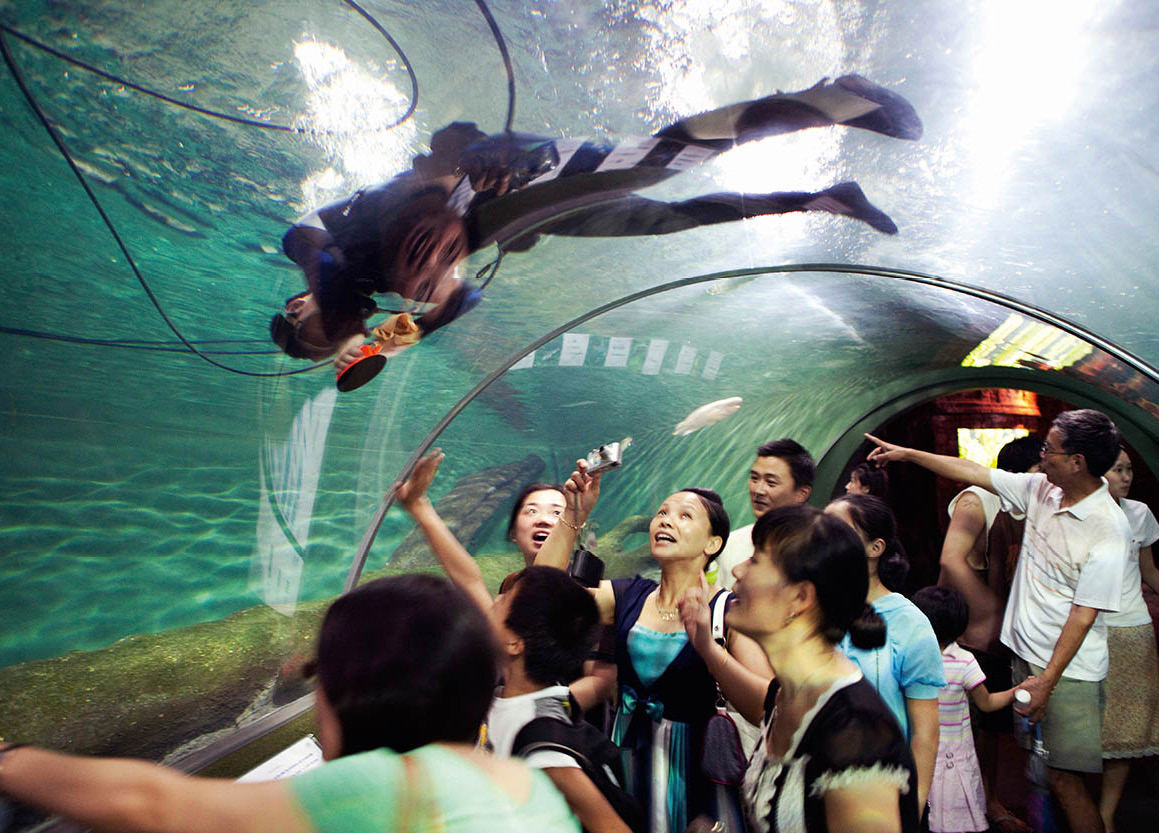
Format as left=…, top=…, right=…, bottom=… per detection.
left=681, top=506, right=918, bottom=831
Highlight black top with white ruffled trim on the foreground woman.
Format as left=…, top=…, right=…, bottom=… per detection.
left=744, top=672, right=919, bottom=832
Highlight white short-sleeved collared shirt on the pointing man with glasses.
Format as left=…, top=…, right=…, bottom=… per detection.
left=990, top=469, right=1131, bottom=681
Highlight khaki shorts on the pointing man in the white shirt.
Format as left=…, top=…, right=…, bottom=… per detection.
left=1011, top=657, right=1107, bottom=773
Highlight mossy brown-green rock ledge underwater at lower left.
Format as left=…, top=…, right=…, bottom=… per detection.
left=0, top=602, right=328, bottom=760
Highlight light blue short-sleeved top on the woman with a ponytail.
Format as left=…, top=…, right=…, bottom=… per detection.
left=840, top=593, right=946, bottom=740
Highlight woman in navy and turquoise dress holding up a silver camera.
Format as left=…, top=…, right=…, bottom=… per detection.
left=535, top=460, right=772, bottom=832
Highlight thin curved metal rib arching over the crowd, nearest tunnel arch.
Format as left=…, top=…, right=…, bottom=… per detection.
left=344, top=263, right=1159, bottom=592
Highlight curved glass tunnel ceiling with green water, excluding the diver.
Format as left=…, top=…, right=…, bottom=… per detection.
left=0, top=0, right=1159, bottom=758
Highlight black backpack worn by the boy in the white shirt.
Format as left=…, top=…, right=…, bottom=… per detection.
left=511, top=716, right=648, bottom=832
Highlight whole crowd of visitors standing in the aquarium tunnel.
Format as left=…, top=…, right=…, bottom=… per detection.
left=0, top=410, right=1159, bottom=832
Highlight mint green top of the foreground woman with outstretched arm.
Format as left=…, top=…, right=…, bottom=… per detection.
left=290, top=745, right=580, bottom=832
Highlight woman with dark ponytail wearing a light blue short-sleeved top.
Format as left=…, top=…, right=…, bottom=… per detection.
left=825, top=495, right=946, bottom=810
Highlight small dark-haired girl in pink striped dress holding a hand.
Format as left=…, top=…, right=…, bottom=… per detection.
left=913, top=585, right=1014, bottom=832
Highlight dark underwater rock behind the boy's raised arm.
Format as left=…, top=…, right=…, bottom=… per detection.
left=389, top=454, right=544, bottom=570
